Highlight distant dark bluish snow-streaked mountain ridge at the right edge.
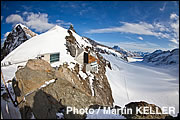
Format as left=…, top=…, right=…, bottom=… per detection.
left=143, top=49, right=179, bottom=65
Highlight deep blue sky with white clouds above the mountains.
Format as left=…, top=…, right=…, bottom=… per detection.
left=1, top=1, right=179, bottom=52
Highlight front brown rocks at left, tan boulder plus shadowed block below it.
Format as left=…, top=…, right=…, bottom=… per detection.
left=15, top=59, right=95, bottom=119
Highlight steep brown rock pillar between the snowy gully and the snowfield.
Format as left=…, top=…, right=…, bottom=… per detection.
left=93, top=54, right=114, bottom=106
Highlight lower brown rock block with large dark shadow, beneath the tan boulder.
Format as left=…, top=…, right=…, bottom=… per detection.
left=19, top=78, right=93, bottom=119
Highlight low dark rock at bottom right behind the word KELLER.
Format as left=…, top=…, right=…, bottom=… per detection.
left=123, top=101, right=172, bottom=119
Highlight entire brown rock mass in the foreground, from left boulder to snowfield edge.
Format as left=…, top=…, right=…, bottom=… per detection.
left=15, top=56, right=113, bottom=119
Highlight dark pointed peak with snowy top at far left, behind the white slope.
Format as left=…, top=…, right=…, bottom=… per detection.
left=1, top=24, right=37, bottom=60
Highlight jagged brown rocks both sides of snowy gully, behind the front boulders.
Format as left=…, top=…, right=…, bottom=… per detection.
left=55, top=55, right=114, bottom=106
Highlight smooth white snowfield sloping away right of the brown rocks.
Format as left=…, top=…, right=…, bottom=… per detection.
left=102, top=54, right=179, bottom=116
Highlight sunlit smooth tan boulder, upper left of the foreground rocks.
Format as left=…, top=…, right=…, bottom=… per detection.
left=16, top=59, right=55, bottom=102
